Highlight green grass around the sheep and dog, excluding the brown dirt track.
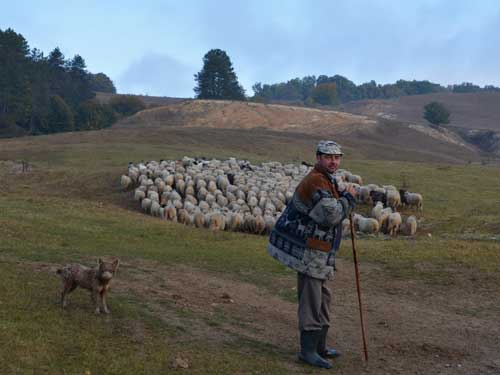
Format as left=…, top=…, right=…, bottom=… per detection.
left=0, top=131, right=500, bottom=374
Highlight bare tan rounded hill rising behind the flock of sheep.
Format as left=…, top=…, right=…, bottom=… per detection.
left=113, top=100, right=479, bottom=162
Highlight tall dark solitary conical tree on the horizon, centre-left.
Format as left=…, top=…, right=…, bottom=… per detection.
left=194, top=49, right=245, bottom=100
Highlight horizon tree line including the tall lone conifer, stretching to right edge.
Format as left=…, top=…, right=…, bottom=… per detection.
left=194, top=49, right=500, bottom=106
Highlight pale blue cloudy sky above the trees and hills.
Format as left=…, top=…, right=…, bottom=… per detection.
left=0, top=0, right=500, bottom=97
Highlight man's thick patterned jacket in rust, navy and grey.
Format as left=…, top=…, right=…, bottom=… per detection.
left=268, top=165, right=353, bottom=279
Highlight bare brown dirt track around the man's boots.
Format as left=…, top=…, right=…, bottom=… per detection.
left=33, top=260, right=500, bottom=375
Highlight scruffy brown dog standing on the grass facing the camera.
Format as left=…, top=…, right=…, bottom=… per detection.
left=56, top=258, right=118, bottom=314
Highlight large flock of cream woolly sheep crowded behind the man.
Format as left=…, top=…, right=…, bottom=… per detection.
left=121, top=157, right=422, bottom=235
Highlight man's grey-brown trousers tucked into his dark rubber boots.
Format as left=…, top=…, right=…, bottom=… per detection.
left=297, top=273, right=332, bottom=331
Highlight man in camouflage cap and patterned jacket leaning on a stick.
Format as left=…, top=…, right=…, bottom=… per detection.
left=268, top=141, right=356, bottom=368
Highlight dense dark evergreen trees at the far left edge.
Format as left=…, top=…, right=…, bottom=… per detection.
left=0, top=28, right=145, bottom=137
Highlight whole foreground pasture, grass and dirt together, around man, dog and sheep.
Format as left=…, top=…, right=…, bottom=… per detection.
left=0, top=129, right=500, bottom=374
